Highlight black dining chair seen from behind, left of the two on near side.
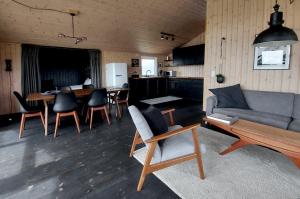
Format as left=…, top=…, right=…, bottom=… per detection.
left=53, top=92, right=80, bottom=137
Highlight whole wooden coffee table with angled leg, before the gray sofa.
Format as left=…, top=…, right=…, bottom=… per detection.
left=204, top=118, right=300, bottom=169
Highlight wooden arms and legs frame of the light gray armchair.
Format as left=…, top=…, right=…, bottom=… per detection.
left=129, top=109, right=205, bottom=191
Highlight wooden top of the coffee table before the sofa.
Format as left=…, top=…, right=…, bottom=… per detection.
left=204, top=118, right=300, bottom=152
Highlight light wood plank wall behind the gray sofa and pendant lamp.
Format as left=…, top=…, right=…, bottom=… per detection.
left=204, top=0, right=300, bottom=107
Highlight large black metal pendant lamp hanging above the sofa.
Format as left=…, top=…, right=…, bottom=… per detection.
left=253, top=0, right=298, bottom=47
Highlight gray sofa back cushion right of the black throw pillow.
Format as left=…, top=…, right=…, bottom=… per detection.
left=243, top=90, right=295, bottom=117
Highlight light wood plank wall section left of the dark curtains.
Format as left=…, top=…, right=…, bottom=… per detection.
left=0, top=43, right=21, bottom=115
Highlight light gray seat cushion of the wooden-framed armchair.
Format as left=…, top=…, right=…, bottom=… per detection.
left=161, top=125, right=195, bottom=161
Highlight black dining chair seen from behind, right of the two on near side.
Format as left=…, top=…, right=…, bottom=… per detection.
left=85, top=88, right=110, bottom=129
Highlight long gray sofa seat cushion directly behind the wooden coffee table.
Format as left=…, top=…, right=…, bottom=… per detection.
left=213, top=108, right=291, bottom=129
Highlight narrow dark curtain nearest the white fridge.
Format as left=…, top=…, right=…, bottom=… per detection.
left=89, top=50, right=101, bottom=88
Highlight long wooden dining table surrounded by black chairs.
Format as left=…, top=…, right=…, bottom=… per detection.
left=26, top=87, right=128, bottom=136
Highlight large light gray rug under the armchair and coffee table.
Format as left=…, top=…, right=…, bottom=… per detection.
left=134, top=128, right=300, bottom=199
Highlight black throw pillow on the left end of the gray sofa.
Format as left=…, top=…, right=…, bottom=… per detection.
left=209, top=84, right=249, bottom=109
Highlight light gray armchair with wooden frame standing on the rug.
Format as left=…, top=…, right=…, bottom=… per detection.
left=128, top=106, right=204, bottom=191
